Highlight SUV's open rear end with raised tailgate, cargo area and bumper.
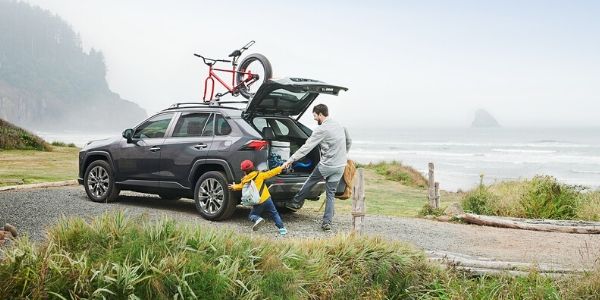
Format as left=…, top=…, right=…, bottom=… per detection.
left=242, top=78, right=348, bottom=201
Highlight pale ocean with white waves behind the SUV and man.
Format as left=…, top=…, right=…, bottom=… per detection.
left=37, top=128, right=600, bottom=191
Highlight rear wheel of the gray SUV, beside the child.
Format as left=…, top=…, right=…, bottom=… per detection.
left=194, top=171, right=237, bottom=221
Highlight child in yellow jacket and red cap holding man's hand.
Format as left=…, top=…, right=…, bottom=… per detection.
left=229, top=160, right=287, bottom=235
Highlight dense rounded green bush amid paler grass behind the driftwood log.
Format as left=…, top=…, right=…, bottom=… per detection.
left=520, top=176, right=580, bottom=220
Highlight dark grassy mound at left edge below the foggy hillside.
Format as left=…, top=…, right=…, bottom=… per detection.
left=0, top=119, right=52, bottom=151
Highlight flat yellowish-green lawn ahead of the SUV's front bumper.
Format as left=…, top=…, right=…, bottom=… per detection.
left=0, top=147, right=79, bottom=186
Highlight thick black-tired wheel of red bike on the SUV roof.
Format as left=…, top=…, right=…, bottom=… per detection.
left=235, top=53, right=273, bottom=99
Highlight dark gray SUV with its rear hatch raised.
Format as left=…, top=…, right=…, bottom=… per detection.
left=78, top=78, right=347, bottom=220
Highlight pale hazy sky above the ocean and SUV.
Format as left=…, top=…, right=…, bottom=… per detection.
left=25, top=0, right=600, bottom=128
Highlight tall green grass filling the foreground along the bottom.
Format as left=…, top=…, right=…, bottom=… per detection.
left=0, top=212, right=600, bottom=299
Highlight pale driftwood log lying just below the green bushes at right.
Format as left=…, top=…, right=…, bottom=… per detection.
left=457, top=213, right=600, bottom=234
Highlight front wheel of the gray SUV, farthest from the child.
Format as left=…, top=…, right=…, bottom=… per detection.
left=83, top=160, right=120, bottom=203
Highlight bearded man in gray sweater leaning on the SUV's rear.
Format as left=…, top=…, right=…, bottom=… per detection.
left=283, top=104, right=352, bottom=231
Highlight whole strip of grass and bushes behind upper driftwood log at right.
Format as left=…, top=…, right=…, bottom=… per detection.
left=461, top=176, right=600, bottom=221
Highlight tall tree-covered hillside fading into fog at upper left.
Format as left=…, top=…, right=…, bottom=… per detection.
left=0, top=0, right=146, bottom=131
